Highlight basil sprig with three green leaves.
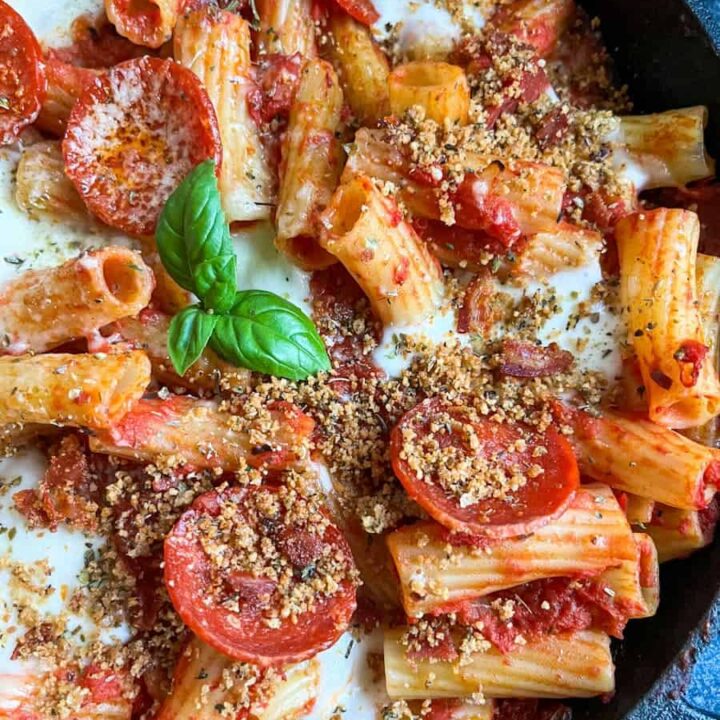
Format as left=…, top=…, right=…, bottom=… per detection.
left=156, top=160, right=330, bottom=380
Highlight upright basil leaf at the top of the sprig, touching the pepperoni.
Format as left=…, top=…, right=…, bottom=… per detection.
left=155, top=160, right=237, bottom=312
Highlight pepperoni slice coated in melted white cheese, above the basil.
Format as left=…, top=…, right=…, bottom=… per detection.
left=63, top=57, right=222, bottom=235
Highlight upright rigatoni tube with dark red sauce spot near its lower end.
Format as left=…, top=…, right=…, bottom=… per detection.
left=615, top=208, right=720, bottom=428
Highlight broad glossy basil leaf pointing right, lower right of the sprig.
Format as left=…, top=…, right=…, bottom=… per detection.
left=210, top=290, right=330, bottom=380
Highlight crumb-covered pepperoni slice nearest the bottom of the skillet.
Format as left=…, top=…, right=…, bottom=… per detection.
left=165, top=486, right=356, bottom=667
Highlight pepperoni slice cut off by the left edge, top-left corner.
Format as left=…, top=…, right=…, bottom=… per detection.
left=0, top=0, right=46, bottom=145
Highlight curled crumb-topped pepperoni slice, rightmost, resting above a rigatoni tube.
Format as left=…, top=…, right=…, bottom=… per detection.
left=390, top=398, right=580, bottom=538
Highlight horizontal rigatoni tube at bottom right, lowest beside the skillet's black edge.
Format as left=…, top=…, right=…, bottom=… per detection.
left=384, top=628, right=615, bottom=700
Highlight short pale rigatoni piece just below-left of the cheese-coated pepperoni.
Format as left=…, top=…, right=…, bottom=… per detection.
left=15, top=140, right=87, bottom=220
